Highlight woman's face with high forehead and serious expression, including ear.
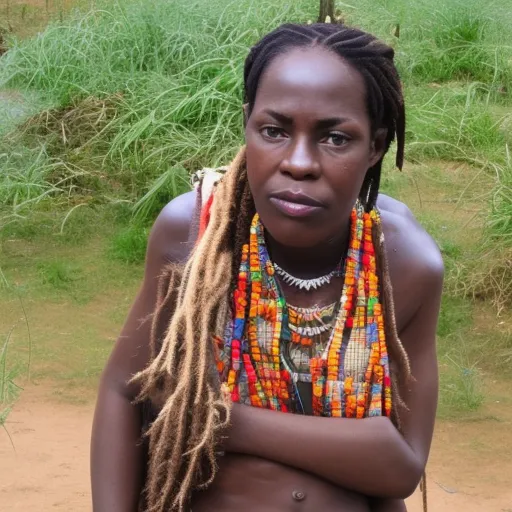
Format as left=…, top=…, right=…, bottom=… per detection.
left=245, top=46, right=385, bottom=248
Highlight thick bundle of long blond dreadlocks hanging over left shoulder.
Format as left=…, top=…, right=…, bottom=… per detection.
left=134, top=149, right=251, bottom=512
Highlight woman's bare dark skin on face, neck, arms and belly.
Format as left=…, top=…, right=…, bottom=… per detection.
left=91, top=47, right=443, bottom=512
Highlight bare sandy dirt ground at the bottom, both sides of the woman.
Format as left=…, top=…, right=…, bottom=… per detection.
left=0, top=386, right=512, bottom=512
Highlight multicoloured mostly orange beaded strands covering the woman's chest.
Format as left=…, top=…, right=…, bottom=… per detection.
left=216, top=203, right=391, bottom=418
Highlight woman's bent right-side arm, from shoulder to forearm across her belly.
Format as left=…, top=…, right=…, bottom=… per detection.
left=226, top=236, right=443, bottom=498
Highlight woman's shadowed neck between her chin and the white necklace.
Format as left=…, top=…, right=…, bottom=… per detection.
left=265, top=226, right=349, bottom=279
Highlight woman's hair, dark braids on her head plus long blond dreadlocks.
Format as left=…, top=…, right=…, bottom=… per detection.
left=134, top=23, right=410, bottom=512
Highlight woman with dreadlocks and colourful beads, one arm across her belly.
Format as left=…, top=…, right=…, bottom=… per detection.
left=92, top=24, right=443, bottom=512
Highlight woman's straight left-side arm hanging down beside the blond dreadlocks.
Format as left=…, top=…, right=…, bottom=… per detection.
left=91, top=194, right=195, bottom=512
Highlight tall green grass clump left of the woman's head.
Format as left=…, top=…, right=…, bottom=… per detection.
left=0, top=0, right=317, bottom=224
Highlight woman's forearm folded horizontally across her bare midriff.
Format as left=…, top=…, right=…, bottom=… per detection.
left=226, top=404, right=416, bottom=498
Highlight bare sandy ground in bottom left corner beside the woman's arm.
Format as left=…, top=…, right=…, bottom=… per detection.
left=0, top=388, right=93, bottom=512
